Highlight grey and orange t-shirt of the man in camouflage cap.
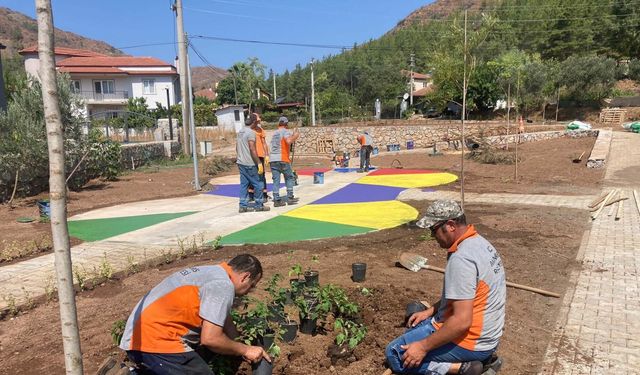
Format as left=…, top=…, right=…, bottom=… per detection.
left=432, top=231, right=507, bottom=351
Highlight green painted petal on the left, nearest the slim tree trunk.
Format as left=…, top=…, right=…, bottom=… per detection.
left=69, top=211, right=197, bottom=242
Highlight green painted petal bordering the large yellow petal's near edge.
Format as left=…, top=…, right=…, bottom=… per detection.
left=220, top=216, right=376, bottom=245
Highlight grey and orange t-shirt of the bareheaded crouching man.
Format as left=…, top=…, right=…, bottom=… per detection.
left=120, top=265, right=235, bottom=353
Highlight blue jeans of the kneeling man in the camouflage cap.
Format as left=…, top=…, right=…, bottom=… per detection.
left=385, top=318, right=495, bottom=374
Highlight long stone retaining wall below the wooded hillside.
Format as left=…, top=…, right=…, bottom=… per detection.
left=296, top=122, right=564, bottom=155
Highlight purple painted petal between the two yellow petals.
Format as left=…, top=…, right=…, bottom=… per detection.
left=312, top=184, right=406, bottom=204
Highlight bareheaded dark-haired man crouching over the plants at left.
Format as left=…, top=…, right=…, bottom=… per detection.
left=120, top=254, right=271, bottom=375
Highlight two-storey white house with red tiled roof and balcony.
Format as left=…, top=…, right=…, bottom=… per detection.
left=20, top=46, right=180, bottom=116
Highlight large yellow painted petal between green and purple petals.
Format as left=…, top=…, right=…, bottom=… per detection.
left=284, top=201, right=418, bottom=229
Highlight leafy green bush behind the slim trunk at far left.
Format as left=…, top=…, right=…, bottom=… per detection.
left=0, top=75, right=124, bottom=202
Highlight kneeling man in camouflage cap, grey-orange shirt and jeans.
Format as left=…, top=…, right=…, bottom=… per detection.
left=386, top=200, right=506, bottom=374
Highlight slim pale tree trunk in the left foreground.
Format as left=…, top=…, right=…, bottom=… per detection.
left=35, top=0, right=83, bottom=375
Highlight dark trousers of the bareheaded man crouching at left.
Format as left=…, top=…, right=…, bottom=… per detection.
left=127, top=350, right=213, bottom=375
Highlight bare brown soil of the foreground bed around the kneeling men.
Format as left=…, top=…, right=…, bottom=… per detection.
left=0, top=202, right=587, bottom=375
